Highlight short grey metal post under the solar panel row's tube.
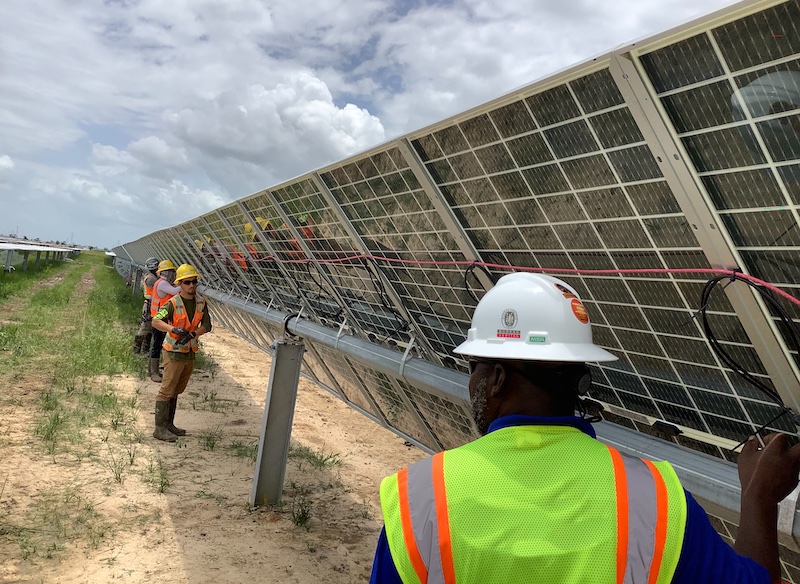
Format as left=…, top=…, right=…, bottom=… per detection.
left=250, top=339, right=305, bottom=507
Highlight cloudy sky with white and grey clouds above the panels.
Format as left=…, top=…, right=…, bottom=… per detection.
left=0, top=0, right=729, bottom=247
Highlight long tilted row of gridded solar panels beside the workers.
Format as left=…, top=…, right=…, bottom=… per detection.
left=115, top=0, right=800, bottom=581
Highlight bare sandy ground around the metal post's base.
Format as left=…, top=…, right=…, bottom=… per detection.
left=0, top=327, right=424, bottom=584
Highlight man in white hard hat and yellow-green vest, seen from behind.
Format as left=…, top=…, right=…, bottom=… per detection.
left=371, top=273, right=800, bottom=584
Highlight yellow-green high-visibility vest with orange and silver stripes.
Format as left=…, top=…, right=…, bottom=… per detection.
left=381, top=425, right=686, bottom=584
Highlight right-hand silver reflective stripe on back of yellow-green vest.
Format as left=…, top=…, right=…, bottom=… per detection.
left=617, top=455, right=658, bottom=584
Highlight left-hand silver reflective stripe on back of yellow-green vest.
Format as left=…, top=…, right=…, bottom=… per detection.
left=408, top=458, right=444, bottom=584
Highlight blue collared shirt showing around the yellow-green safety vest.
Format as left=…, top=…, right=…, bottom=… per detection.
left=369, top=414, right=771, bottom=584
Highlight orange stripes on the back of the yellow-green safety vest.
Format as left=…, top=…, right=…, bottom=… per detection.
left=397, top=447, right=669, bottom=584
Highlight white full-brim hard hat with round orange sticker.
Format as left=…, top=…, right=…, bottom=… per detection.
left=453, top=272, right=617, bottom=362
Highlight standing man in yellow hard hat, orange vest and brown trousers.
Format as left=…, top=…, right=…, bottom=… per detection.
left=153, top=264, right=211, bottom=442
